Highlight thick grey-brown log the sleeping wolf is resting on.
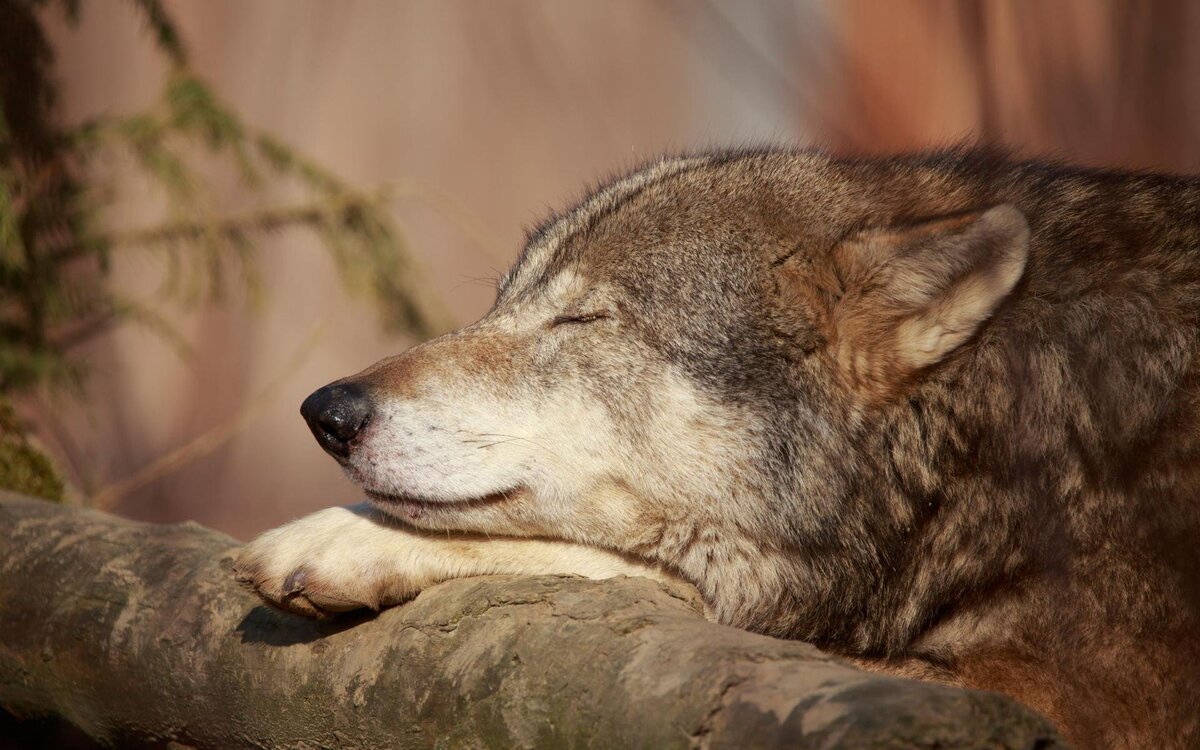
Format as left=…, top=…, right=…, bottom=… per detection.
left=0, top=496, right=1061, bottom=750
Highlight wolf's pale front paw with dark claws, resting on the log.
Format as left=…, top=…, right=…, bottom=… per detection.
left=234, top=508, right=415, bottom=618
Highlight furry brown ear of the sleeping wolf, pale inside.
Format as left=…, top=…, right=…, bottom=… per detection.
left=829, top=205, right=1030, bottom=392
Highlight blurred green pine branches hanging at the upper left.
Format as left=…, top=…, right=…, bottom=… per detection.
left=0, top=0, right=454, bottom=412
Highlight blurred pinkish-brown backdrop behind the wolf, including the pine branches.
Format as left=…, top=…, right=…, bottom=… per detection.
left=0, top=0, right=1200, bottom=538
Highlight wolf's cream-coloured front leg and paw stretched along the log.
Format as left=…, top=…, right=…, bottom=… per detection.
left=234, top=504, right=682, bottom=618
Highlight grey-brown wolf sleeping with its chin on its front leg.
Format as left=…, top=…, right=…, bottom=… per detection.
left=235, top=149, right=1200, bottom=748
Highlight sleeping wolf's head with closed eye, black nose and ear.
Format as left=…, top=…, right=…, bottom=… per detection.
left=302, top=152, right=1028, bottom=637
